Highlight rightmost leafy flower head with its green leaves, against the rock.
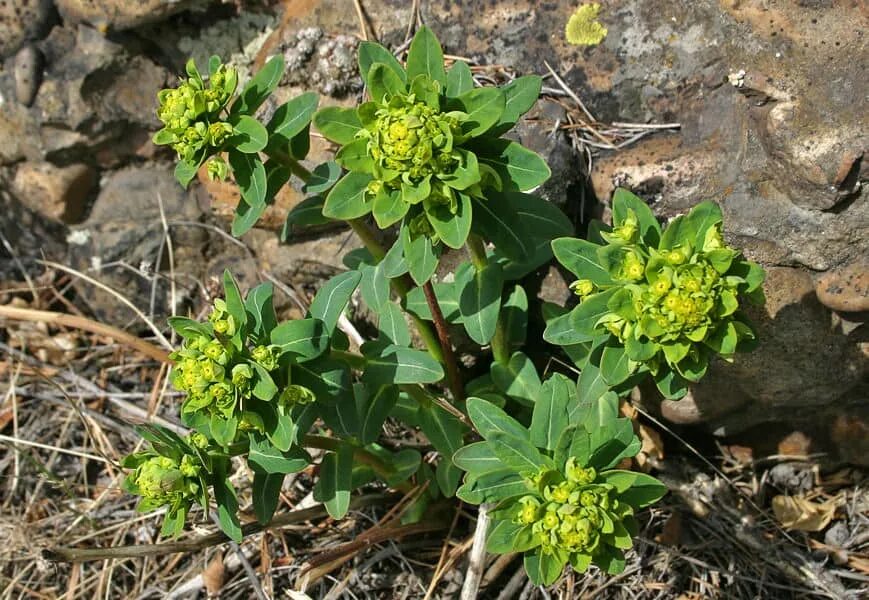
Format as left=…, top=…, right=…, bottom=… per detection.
left=543, top=189, right=764, bottom=398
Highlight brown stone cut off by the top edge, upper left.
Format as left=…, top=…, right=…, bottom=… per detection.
left=56, top=0, right=204, bottom=31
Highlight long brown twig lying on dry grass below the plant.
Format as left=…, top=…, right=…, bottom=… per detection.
left=42, top=494, right=398, bottom=563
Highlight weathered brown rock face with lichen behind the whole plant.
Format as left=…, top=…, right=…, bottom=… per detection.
left=0, top=0, right=869, bottom=465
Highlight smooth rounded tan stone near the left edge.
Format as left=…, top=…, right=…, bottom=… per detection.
left=12, top=162, right=96, bottom=224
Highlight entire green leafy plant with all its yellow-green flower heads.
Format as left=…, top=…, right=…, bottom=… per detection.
left=118, top=28, right=762, bottom=583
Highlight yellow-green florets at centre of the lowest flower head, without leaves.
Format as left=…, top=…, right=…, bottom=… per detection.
left=513, top=457, right=633, bottom=559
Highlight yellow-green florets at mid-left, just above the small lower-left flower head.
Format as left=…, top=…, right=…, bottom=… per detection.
left=170, top=299, right=280, bottom=419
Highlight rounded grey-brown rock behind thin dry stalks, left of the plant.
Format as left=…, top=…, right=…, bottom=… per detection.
left=68, top=165, right=208, bottom=328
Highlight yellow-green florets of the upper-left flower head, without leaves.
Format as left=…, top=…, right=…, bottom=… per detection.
left=154, top=60, right=238, bottom=163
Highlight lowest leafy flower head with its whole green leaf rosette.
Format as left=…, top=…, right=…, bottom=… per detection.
left=453, top=382, right=667, bottom=584
